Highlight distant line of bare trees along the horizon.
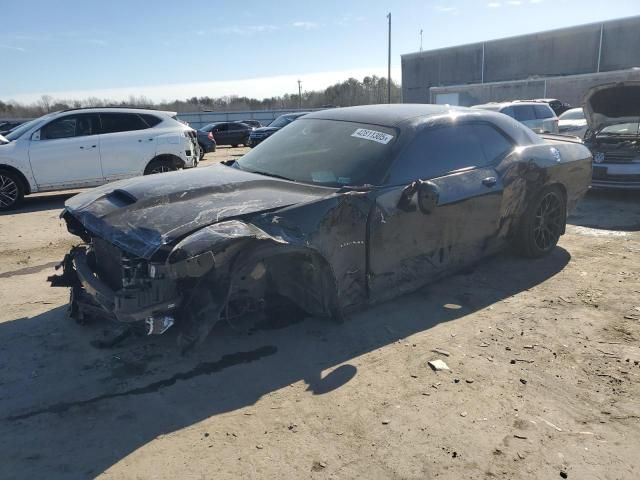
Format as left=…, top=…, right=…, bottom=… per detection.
left=0, top=75, right=402, bottom=118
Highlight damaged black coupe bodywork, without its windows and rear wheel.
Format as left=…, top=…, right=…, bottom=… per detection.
left=54, top=105, right=591, bottom=344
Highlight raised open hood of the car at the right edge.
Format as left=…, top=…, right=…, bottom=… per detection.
left=583, top=81, right=640, bottom=132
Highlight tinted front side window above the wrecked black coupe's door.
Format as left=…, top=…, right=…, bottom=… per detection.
left=389, top=124, right=487, bottom=184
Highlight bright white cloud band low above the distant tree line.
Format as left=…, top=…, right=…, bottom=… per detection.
left=3, top=66, right=401, bottom=103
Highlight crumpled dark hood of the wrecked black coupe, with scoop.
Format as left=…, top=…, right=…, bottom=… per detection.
left=63, top=165, right=335, bottom=259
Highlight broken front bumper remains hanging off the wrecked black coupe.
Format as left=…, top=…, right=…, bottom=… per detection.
left=48, top=246, right=181, bottom=328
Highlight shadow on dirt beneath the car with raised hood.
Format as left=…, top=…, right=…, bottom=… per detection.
left=568, top=189, right=640, bottom=232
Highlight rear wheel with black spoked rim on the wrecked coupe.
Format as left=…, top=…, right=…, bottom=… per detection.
left=516, top=186, right=567, bottom=258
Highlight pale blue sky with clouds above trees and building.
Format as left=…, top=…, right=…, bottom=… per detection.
left=0, top=0, right=640, bottom=101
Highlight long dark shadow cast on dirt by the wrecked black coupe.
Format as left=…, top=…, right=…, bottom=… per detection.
left=0, top=247, right=570, bottom=479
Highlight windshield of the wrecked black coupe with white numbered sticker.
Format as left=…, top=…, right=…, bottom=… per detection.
left=236, top=118, right=397, bottom=187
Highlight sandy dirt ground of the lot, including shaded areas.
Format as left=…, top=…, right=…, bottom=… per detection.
left=0, top=148, right=640, bottom=480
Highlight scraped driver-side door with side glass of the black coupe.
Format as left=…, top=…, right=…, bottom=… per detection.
left=368, top=124, right=513, bottom=299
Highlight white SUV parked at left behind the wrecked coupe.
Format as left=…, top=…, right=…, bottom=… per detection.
left=0, top=108, right=199, bottom=210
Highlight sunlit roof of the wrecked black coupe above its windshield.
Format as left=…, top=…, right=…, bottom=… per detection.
left=305, top=103, right=469, bottom=126
